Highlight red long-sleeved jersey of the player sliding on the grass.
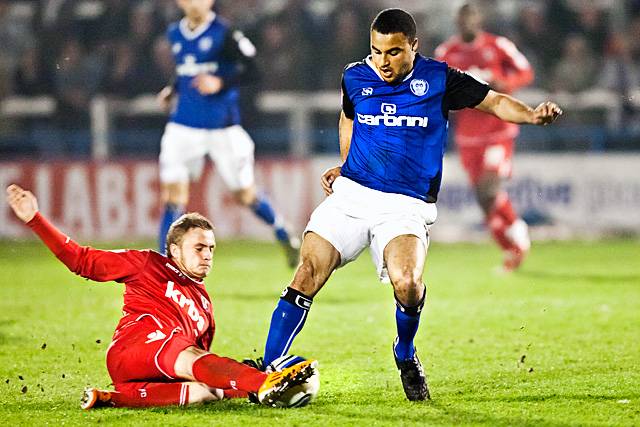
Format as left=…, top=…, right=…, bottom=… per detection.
left=27, top=213, right=215, bottom=351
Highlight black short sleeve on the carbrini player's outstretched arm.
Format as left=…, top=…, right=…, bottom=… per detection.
left=442, top=67, right=490, bottom=113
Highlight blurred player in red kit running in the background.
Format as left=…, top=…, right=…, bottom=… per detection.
left=435, top=3, right=533, bottom=271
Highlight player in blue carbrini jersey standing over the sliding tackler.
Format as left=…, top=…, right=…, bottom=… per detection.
left=264, top=9, right=562, bottom=400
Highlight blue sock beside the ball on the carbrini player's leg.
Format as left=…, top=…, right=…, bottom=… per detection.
left=264, top=288, right=313, bottom=366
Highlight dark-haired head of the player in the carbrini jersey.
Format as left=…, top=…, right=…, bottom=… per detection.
left=371, top=9, right=418, bottom=83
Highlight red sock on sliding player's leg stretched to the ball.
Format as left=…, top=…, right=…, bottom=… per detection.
left=192, top=353, right=267, bottom=393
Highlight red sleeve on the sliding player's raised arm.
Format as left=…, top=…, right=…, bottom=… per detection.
left=27, top=212, right=150, bottom=282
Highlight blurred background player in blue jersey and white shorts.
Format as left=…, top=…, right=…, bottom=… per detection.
left=158, top=0, right=300, bottom=267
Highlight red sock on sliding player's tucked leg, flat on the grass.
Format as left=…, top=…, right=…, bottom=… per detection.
left=111, top=383, right=189, bottom=408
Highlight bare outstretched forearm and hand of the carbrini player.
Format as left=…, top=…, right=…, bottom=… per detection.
left=475, top=90, right=562, bottom=125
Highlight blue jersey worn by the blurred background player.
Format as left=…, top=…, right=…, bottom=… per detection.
left=167, top=12, right=255, bottom=129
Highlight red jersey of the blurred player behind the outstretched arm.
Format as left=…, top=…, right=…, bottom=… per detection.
left=435, top=32, right=533, bottom=146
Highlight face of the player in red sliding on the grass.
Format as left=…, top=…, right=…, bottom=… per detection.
left=171, top=228, right=216, bottom=279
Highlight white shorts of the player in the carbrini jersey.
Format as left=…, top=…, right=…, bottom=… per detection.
left=305, top=176, right=438, bottom=281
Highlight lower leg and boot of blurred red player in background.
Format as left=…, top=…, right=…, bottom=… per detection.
left=487, top=191, right=531, bottom=271
